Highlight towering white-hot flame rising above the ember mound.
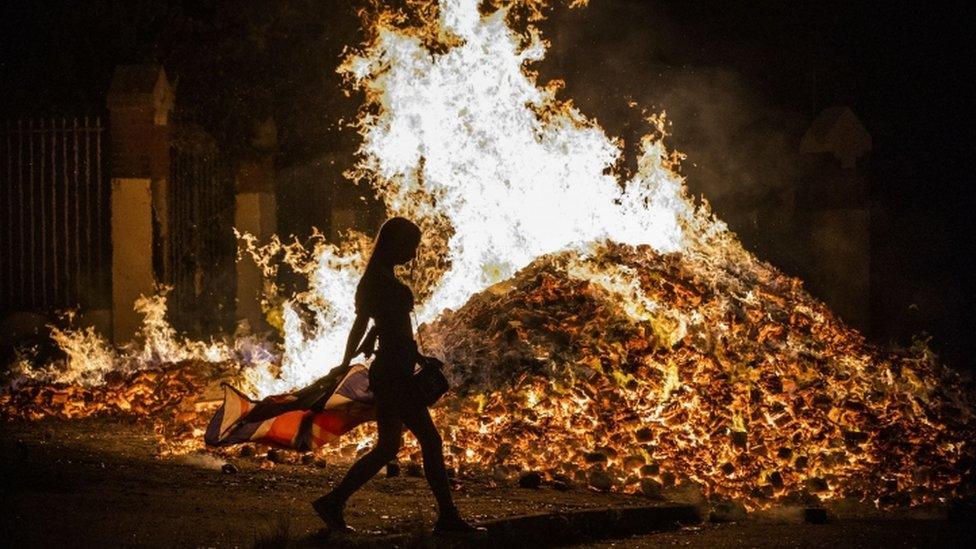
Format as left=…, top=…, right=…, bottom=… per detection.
left=343, top=0, right=694, bottom=321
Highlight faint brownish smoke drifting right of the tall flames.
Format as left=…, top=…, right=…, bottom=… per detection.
left=540, top=2, right=805, bottom=268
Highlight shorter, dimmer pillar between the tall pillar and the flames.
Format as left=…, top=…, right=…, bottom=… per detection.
left=234, top=153, right=278, bottom=331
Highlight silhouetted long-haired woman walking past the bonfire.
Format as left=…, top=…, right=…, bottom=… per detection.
left=312, top=217, right=476, bottom=533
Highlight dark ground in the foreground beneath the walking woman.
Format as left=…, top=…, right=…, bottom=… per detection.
left=0, top=419, right=976, bottom=548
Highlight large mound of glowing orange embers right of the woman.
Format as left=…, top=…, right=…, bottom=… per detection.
left=421, top=240, right=976, bottom=506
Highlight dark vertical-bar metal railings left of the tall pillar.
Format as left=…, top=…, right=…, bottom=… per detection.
left=0, top=117, right=112, bottom=311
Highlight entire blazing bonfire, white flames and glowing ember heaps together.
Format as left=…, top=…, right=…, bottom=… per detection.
left=0, top=0, right=976, bottom=510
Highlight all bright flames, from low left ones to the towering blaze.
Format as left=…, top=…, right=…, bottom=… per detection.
left=13, top=0, right=708, bottom=396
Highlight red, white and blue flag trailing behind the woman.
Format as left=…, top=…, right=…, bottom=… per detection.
left=204, top=364, right=376, bottom=452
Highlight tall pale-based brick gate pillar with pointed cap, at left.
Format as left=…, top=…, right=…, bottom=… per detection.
left=108, top=65, right=173, bottom=343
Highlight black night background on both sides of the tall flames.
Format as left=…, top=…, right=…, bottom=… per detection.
left=0, top=0, right=976, bottom=369
